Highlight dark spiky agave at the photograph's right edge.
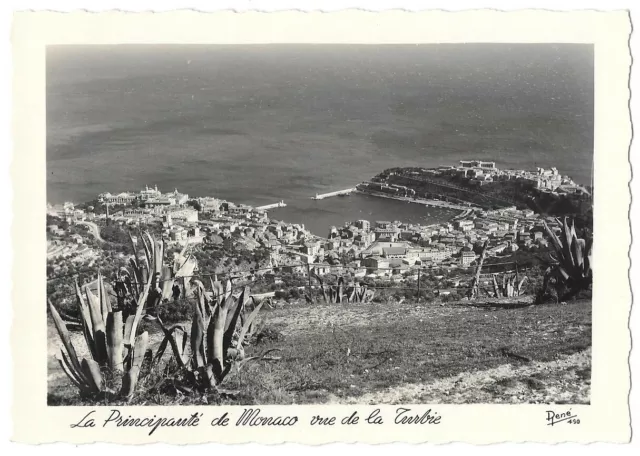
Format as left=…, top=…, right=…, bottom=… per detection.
left=540, top=217, right=593, bottom=301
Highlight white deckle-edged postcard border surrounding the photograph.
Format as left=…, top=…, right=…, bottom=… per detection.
left=12, top=10, right=631, bottom=444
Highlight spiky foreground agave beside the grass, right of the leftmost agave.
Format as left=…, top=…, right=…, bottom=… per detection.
left=148, top=280, right=266, bottom=390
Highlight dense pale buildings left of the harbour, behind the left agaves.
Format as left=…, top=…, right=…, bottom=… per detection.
left=48, top=187, right=319, bottom=265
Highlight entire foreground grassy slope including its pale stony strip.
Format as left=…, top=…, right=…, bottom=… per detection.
left=50, top=301, right=591, bottom=404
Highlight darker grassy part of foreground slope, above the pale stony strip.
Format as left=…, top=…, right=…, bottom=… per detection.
left=221, top=302, right=591, bottom=403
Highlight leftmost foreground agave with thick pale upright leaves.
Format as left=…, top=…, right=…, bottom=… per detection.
left=49, top=275, right=149, bottom=397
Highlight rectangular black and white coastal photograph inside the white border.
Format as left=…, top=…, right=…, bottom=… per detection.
left=42, top=43, right=598, bottom=406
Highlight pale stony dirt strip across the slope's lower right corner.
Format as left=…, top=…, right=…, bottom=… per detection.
left=329, top=349, right=591, bottom=404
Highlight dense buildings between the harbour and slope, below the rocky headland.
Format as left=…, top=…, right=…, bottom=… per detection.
left=302, top=207, right=559, bottom=277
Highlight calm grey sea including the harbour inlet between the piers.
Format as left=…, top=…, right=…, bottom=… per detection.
left=46, top=44, right=594, bottom=236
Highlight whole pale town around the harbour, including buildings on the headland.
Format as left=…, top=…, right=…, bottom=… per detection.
left=48, top=161, right=588, bottom=280
